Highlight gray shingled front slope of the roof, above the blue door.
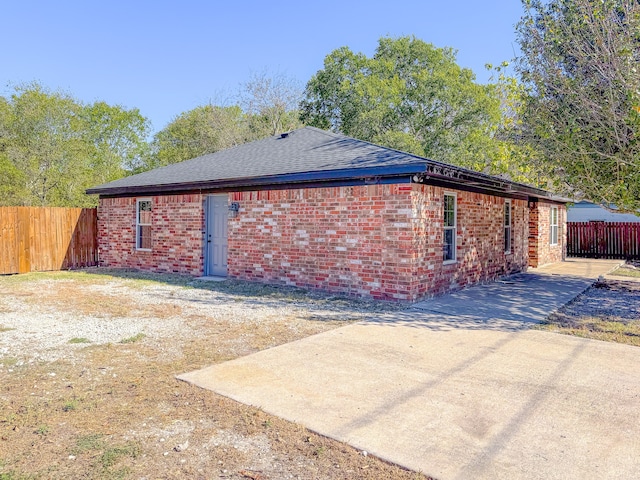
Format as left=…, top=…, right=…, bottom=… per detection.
left=87, top=127, right=427, bottom=194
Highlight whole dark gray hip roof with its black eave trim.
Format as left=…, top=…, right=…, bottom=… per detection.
left=87, top=127, right=570, bottom=203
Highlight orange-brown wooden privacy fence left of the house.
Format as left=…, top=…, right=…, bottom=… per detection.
left=0, top=207, right=98, bottom=274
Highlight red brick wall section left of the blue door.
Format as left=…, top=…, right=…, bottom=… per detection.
left=98, top=194, right=204, bottom=275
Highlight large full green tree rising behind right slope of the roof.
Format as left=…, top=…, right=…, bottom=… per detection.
left=301, top=37, right=501, bottom=170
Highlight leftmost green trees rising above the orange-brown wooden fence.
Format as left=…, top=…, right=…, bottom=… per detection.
left=0, top=83, right=148, bottom=206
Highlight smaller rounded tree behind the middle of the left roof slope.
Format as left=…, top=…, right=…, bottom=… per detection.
left=149, top=105, right=252, bottom=170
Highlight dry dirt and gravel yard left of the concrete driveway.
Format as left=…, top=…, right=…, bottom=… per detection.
left=0, top=270, right=426, bottom=480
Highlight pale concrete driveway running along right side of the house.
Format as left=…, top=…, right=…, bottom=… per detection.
left=179, top=262, right=640, bottom=480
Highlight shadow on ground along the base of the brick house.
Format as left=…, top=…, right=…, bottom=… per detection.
left=77, top=268, right=593, bottom=331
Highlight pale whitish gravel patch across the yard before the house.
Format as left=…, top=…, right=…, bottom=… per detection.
left=0, top=274, right=384, bottom=362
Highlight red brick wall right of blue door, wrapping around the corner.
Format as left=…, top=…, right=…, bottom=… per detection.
left=229, top=184, right=528, bottom=301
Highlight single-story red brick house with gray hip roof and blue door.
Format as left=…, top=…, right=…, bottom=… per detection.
left=87, top=127, right=566, bottom=301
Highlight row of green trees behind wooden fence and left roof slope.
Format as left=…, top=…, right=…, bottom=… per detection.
left=0, top=73, right=301, bottom=202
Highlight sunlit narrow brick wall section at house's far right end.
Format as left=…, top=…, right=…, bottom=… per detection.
left=529, top=198, right=567, bottom=268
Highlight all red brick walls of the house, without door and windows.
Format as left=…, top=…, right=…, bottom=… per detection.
left=98, top=184, right=552, bottom=301
